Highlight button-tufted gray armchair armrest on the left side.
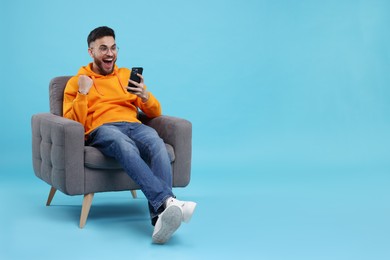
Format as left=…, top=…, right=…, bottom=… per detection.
left=31, top=113, right=84, bottom=195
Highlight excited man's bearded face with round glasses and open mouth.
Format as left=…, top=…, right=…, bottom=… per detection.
left=88, top=36, right=117, bottom=75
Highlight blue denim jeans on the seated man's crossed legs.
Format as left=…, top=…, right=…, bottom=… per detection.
left=86, top=122, right=174, bottom=221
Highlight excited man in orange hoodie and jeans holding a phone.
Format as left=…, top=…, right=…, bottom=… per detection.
left=63, top=26, right=196, bottom=244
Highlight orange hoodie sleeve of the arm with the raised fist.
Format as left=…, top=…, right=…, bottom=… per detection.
left=63, top=76, right=88, bottom=126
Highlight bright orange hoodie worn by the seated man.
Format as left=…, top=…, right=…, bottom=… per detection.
left=63, top=63, right=161, bottom=135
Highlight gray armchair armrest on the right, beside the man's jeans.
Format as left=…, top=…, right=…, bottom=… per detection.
left=140, top=115, right=192, bottom=187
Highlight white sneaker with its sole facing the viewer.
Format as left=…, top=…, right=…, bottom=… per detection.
left=152, top=205, right=183, bottom=244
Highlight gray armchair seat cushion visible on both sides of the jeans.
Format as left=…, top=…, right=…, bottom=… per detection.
left=84, top=144, right=175, bottom=169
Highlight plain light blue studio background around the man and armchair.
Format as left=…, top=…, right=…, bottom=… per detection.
left=0, top=0, right=390, bottom=259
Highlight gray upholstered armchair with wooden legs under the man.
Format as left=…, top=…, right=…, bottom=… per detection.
left=31, top=76, right=192, bottom=228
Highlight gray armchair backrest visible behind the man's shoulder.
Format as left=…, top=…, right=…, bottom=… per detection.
left=49, top=76, right=71, bottom=116
